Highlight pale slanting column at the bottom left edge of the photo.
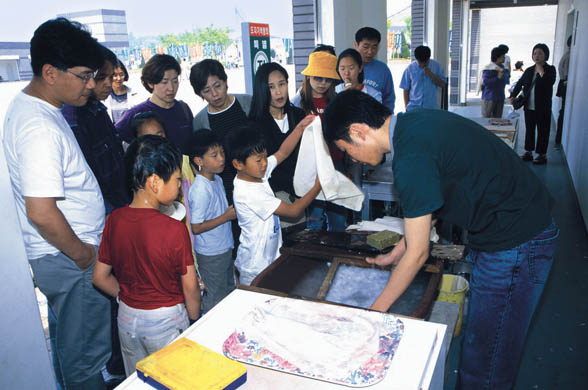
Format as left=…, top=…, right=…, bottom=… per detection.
left=0, top=148, right=55, bottom=389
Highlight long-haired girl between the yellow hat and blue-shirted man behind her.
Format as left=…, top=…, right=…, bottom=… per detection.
left=335, top=49, right=382, bottom=103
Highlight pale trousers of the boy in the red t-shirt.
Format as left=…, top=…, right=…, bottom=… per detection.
left=118, top=301, right=190, bottom=376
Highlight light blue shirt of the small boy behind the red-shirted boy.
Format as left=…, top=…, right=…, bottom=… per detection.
left=188, top=175, right=234, bottom=256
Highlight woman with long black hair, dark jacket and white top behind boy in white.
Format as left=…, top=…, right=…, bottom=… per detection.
left=249, top=62, right=306, bottom=200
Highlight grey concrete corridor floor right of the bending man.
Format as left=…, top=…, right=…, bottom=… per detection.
left=445, top=100, right=588, bottom=390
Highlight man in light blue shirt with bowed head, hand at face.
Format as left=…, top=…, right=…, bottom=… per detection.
left=400, top=46, right=447, bottom=111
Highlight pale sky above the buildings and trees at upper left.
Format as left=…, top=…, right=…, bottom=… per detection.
left=0, top=0, right=292, bottom=42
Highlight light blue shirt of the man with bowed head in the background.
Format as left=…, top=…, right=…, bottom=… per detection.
left=400, top=58, right=445, bottom=112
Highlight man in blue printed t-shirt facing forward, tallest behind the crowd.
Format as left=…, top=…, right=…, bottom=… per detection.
left=354, top=27, right=396, bottom=113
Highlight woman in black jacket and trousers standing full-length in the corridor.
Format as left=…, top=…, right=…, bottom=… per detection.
left=509, top=43, right=556, bottom=165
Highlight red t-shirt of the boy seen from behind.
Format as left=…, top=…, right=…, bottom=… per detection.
left=98, top=206, right=194, bottom=310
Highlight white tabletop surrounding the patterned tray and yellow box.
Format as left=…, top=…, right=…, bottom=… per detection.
left=117, top=289, right=446, bottom=390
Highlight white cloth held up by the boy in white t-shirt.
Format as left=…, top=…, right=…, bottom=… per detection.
left=294, top=116, right=364, bottom=211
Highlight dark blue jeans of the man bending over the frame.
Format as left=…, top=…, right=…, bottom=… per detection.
left=458, top=221, right=559, bottom=390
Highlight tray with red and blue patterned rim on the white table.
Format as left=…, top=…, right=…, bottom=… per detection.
left=223, top=298, right=404, bottom=387
